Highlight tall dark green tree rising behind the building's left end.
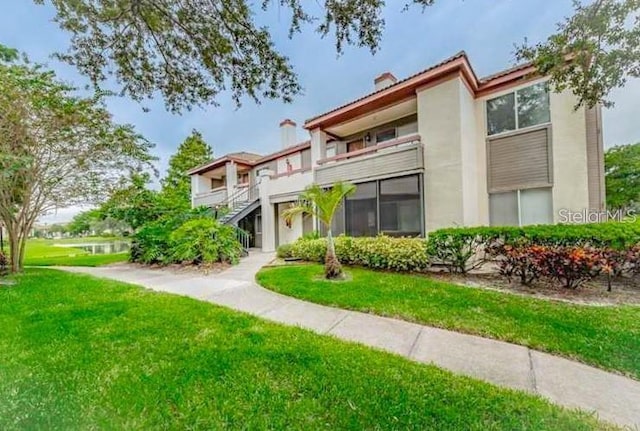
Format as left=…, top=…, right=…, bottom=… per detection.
left=161, top=130, right=213, bottom=210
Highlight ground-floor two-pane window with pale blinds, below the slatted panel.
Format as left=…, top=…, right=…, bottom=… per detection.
left=489, top=188, right=553, bottom=226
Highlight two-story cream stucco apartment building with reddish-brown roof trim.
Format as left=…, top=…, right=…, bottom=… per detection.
left=189, top=52, right=604, bottom=251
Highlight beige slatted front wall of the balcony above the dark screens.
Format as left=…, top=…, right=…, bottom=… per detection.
left=315, top=134, right=424, bottom=184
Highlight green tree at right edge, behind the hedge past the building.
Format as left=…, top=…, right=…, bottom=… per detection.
left=604, top=143, right=640, bottom=210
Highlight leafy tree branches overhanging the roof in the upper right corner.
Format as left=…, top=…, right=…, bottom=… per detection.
left=516, top=0, right=640, bottom=108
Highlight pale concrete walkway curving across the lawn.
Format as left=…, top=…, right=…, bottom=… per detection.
left=60, top=252, right=640, bottom=429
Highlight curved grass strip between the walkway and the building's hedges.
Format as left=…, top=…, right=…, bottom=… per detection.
left=257, top=265, right=640, bottom=378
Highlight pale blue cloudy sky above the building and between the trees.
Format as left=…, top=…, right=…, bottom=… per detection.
left=0, top=0, right=640, bottom=223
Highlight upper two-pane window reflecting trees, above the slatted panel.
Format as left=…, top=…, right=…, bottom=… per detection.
left=487, top=82, right=551, bottom=135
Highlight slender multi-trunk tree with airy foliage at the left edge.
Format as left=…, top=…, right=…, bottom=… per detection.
left=0, top=51, right=153, bottom=272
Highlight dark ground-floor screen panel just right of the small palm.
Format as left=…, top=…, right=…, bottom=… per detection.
left=345, top=181, right=378, bottom=236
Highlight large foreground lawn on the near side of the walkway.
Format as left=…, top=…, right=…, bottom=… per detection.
left=0, top=269, right=606, bottom=430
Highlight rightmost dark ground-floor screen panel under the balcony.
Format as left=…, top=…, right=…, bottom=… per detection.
left=380, top=176, right=422, bottom=236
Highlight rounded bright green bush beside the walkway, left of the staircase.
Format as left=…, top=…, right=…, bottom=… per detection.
left=169, top=218, right=242, bottom=265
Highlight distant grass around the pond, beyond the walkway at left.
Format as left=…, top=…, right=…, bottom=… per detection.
left=0, top=237, right=129, bottom=266
